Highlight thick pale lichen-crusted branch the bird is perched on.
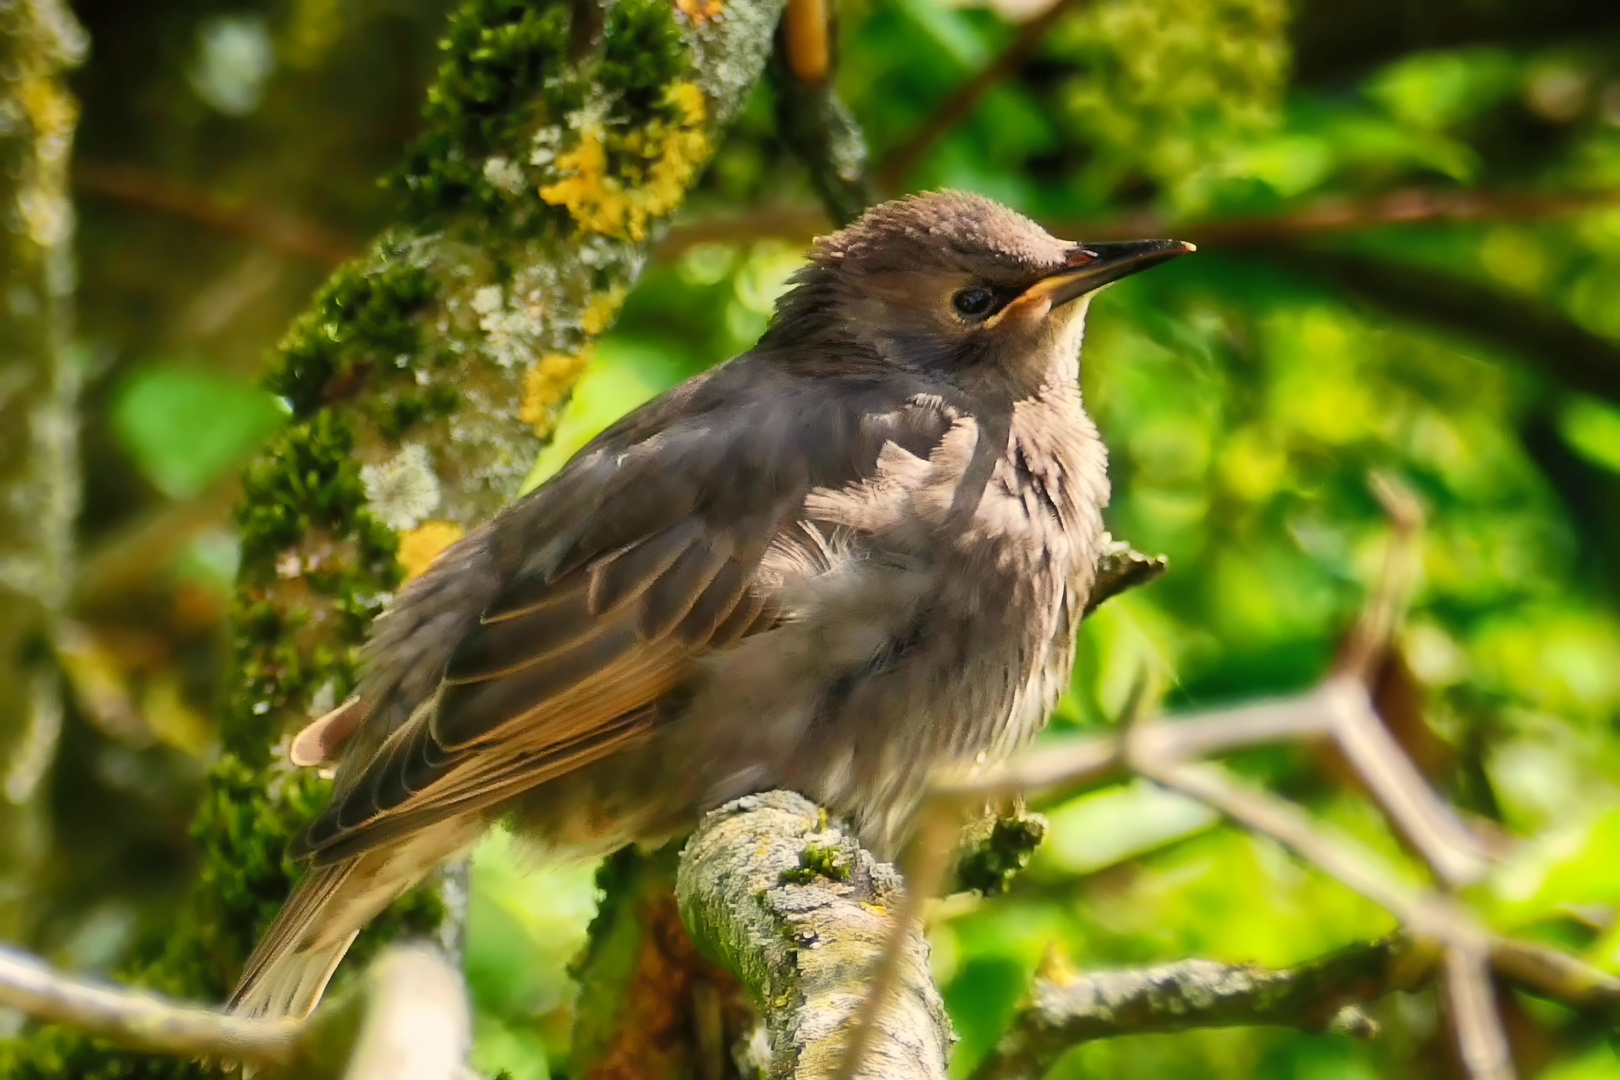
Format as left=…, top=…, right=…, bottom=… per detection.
left=677, top=792, right=953, bottom=1080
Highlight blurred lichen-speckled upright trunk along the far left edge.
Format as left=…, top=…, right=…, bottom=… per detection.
left=0, top=0, right=86, bottom=941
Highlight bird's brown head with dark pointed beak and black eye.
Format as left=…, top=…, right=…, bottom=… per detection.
left=765, top=191, right=1192, bottom=396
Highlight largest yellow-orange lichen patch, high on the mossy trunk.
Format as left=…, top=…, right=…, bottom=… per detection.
left=539, top=81, right=710, bottom=243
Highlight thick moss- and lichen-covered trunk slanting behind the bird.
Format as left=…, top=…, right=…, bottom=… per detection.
left=3, top=0, right=781, bottom=1078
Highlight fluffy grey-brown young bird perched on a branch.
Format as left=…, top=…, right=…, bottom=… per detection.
left=230, top=191, right=1194, bottom=1017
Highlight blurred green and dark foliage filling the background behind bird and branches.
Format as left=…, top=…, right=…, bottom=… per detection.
left=9, top=0, right=1620, bottom=1080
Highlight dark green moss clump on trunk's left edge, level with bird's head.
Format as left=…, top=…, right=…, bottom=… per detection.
left=266, top=250, right=434, bottom=418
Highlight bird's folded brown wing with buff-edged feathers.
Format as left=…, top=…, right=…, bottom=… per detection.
left=291, top=369, right=956, bottom=863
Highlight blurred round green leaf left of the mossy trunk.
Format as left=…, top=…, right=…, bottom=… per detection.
left=112, top=364, right=287, bottom=499
